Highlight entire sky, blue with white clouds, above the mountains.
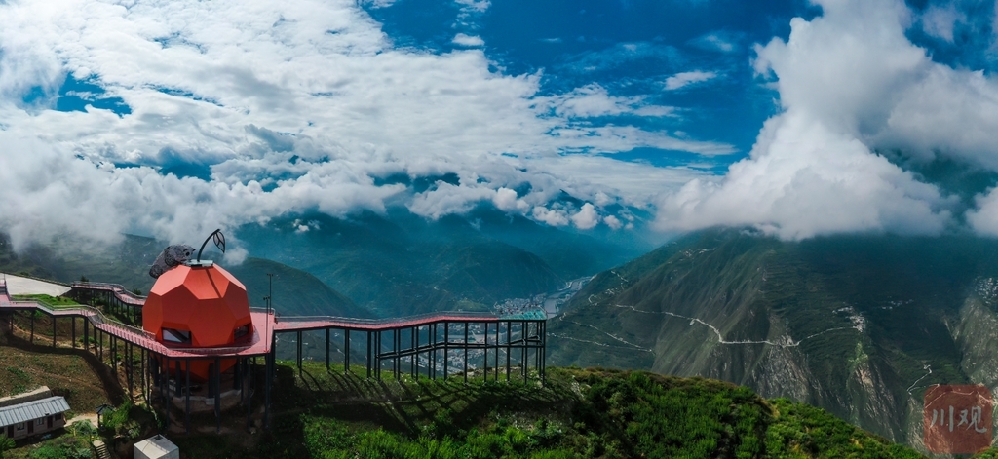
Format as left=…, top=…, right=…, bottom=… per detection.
left=0, top=0, right=998, bottom=250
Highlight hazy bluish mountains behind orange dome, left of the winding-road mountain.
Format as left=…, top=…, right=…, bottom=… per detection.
left=0, top=209, right=650, bottom=317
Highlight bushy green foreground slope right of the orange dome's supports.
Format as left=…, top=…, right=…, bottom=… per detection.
left=176, top=363, right=922, bottom=458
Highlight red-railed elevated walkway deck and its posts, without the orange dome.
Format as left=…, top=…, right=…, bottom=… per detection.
left=0, top=278, right=547, bottom=432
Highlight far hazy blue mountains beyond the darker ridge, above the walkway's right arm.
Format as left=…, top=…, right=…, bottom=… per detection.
left=238, top=213, right=588, bottom=316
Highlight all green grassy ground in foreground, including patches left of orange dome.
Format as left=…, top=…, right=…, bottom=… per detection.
left=0, top=302, right=936, bottom=459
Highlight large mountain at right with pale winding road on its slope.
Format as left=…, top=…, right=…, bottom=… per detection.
left=551, top=230, right=998, bottom=445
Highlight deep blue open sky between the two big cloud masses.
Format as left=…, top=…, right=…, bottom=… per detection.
left=366, top=0, right=816, bottom=172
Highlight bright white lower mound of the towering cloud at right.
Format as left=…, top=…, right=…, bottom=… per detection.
left=657, top=111, right=952, bottom=240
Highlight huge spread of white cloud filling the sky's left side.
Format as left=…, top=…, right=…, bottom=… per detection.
left=0, top=0, right=735, bottom=248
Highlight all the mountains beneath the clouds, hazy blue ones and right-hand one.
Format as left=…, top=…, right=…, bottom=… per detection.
left=0, top=218, right=998, bottom=447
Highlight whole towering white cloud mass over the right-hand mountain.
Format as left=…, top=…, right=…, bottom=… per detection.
left=656, top=0, right=998, bottom=240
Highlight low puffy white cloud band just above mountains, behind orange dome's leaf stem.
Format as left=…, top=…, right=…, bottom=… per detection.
left=0, top=132, right=410, bottom=249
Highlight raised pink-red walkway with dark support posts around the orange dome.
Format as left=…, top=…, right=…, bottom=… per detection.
left=0, top=279, right=547, bottom=436
